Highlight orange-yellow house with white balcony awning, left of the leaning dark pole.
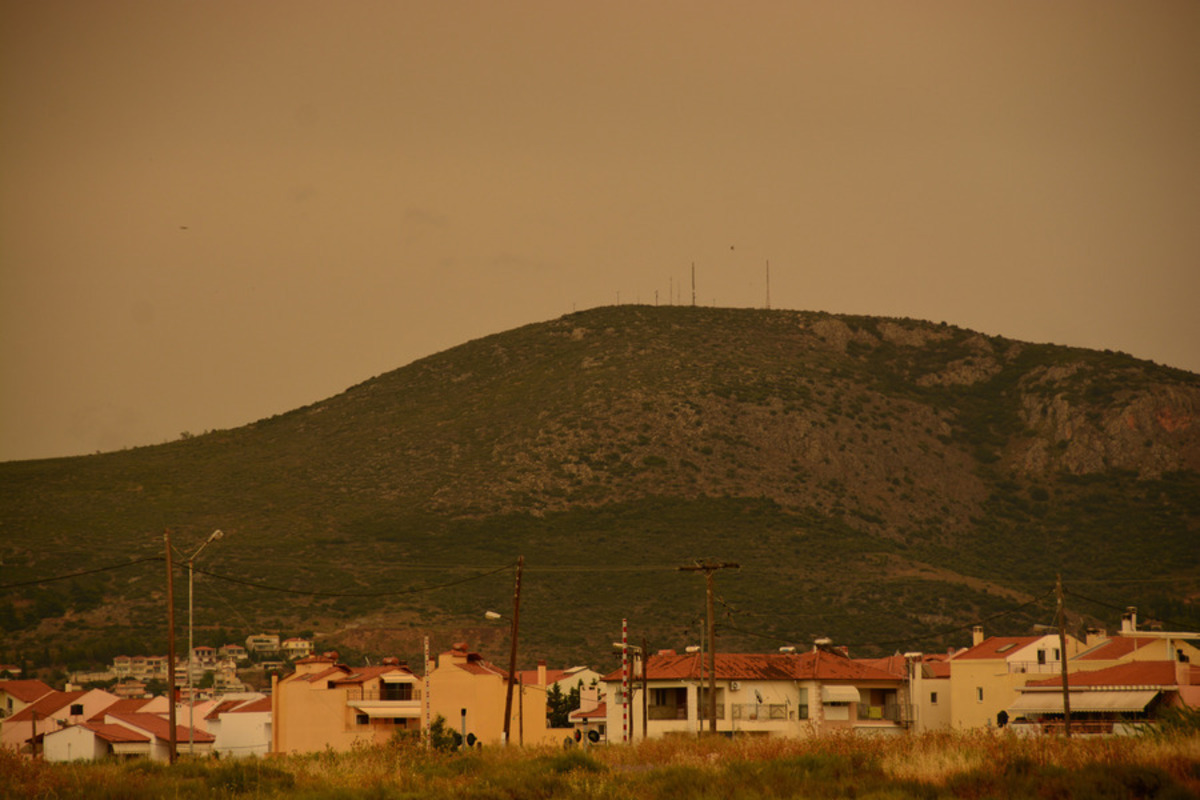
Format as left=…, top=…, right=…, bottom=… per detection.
left=270, top=652, right=422, bottom=753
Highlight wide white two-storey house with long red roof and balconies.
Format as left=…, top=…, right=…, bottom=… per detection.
left=605, top=648, right=906, bottom=742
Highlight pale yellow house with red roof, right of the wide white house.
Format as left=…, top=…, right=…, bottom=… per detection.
left=949, top=626, right=1084, bottom=729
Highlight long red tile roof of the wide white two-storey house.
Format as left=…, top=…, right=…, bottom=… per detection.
left=604, top=650, right=902, bottom=682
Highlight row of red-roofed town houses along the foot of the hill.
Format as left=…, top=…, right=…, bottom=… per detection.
left=0, top=613, right=1200, bottom=760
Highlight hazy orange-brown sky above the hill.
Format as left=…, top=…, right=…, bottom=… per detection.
left=0, top=0, right=1200, bottom=459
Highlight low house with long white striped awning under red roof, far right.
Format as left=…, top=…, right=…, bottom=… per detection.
left=1008, top=661, right=1200, bottom=734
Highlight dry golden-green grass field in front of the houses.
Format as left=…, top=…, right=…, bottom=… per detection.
left=0, top=732, right=1200, bottom=800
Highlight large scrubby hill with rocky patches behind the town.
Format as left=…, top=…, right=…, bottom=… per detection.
left=0, top=306, right=1200, bottom=666
